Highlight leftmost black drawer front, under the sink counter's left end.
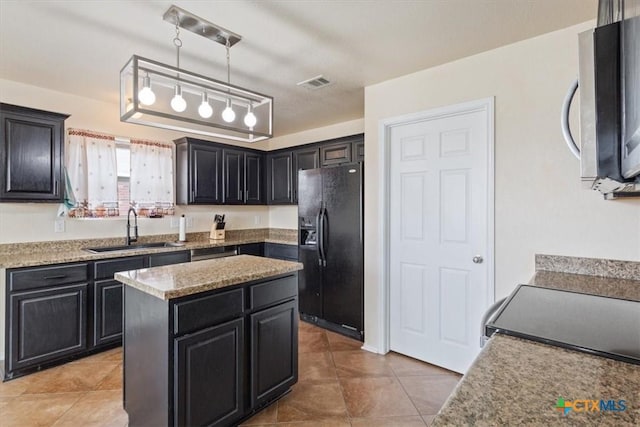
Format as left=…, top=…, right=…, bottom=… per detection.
left=7, top=263, right=88, bottom=292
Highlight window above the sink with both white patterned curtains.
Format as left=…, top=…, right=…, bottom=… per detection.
left=65, top=129, right=175, bottom=218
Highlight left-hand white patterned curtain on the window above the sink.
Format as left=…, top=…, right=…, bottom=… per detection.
left=65, top=129, right=118, bottom=217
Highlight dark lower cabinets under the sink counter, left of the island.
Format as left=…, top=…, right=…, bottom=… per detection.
left=2, top=251, right=190, bottom=379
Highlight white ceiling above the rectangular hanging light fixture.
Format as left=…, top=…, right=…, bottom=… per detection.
left=0, top=0, right=597, bottom=136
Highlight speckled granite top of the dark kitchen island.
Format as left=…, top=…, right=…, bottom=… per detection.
left=115, top=255, right=303, bottom=300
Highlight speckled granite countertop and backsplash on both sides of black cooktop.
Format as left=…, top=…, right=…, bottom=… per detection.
left=432, top=255, right=640, bottom=427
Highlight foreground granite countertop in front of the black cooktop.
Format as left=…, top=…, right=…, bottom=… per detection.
left=431, top=334, right=640, bottom=426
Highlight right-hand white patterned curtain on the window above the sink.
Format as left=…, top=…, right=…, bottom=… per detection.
left=129, top=139, right=174, bottom=217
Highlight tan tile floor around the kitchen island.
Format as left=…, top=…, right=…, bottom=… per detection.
left=0, top=322, right=460, bottom=427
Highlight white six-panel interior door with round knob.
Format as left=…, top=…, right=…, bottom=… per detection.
left=388, top=102, right=493, bottom=372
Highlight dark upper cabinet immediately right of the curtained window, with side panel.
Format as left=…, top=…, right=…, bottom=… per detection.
left=176, top=138, right=222, bottom=205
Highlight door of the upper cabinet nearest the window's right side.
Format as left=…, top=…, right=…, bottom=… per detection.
left=189, top=143, right=222, bottom=204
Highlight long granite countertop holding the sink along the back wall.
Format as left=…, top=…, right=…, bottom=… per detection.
left=0, top=229, right=297, bottom=268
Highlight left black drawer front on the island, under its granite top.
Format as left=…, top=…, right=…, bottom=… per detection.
left=173, top=289, right=244, bottom=335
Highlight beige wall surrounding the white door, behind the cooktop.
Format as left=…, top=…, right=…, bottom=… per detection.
left=365, top=23, right=640, bottom=349
